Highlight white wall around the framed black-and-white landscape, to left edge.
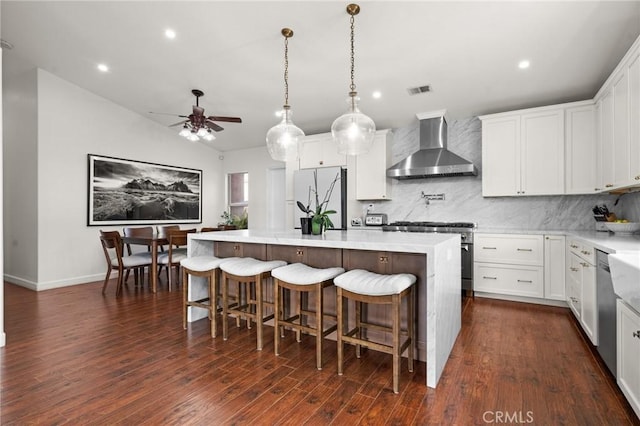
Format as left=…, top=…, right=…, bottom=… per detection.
left=4, top=70, right=224, bottom=290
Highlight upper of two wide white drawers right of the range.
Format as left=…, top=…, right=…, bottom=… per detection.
left=474, top=234, right=544, bottom=266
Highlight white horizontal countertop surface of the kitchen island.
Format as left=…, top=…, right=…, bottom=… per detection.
left=189, top=229, right=460, bottom=253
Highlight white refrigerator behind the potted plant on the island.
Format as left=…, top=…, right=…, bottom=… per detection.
left=293, top=167, right=347, bottom=229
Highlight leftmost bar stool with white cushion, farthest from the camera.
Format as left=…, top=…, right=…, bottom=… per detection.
left=180, top=256, right=237, bottom=337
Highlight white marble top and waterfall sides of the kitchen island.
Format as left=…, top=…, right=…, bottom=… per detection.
left=188, top=230, right=461, bottom=388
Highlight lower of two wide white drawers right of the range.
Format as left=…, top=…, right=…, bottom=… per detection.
left=474, top=263, right=544, bottom=297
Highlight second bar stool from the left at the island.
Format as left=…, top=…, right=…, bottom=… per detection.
left=220, top=257, right=287, bottom=351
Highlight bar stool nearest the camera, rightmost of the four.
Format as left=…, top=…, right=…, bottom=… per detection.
left=334, top=269, right=416, bottom=393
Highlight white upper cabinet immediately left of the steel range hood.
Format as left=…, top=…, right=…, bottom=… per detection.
left=355, top=130, right=393, bottom=200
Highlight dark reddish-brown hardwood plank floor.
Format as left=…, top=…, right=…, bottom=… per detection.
left=0, top=280, right=640, bottom=425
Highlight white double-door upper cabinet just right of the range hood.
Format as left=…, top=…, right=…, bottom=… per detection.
left=480, top=106, right=565, bottom=197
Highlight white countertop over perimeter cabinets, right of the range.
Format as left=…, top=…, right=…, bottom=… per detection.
left=476, top=228, right=640, bottom=253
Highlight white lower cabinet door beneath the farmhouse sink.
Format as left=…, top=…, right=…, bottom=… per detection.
left=617, top=300, right=640, bottom=418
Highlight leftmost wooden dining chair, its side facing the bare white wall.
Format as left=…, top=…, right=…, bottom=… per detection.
left=100, top=230, right=151, bottom=297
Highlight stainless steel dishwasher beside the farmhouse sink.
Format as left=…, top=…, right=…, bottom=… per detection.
left=596, top=250, right=618, bottom=376
